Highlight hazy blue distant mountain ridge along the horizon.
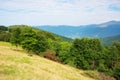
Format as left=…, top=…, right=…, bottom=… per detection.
left=35, top=21, right=120, bottom=38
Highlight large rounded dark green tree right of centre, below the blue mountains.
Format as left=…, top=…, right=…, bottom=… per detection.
left=66, top=38, right=102, bottom=69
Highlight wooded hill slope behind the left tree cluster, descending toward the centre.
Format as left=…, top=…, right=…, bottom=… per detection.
left=0, top=25, right=73, bottom=42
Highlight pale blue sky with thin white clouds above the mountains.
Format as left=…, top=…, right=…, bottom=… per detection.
left=0, top=0, right=120, bottom=25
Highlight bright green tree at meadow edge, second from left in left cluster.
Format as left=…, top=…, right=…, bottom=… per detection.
left=20, top=27, right=37, bottom=53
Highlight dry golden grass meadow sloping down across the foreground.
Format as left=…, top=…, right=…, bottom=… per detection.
left=0, top=42, right=94, bottom=80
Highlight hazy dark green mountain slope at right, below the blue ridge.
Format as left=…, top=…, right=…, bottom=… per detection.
left=100, top=35, right=120, bottom=46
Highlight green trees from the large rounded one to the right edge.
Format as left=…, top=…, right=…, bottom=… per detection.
left=63, top=38, right=120, bottom=79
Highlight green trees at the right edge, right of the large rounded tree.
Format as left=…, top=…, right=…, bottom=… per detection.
left=98, top=42, right=120, bottom=80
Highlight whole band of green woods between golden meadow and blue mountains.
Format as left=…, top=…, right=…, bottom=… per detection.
left=0, top=25, right=120, bottom=80
